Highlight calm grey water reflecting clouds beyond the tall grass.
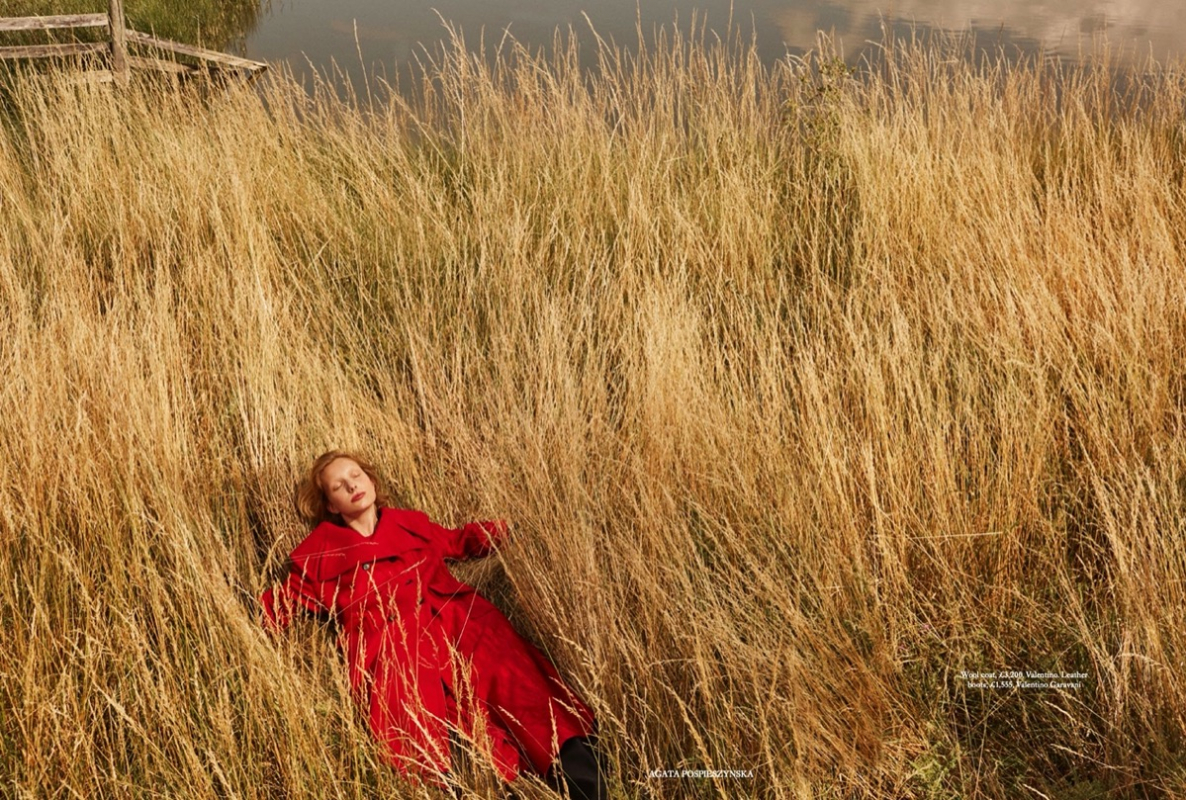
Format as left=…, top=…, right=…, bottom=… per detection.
left=242, top=0, right=1186, bottom=88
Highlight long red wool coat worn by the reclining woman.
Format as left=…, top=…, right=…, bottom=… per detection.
left=260, top=508, right=594, bottom=785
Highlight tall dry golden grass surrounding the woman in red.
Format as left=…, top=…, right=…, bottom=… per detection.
left=0, top=23, right=1186, bottom=799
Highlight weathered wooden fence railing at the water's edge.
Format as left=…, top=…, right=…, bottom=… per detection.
left=0, top=0, right=268, bottom=82
